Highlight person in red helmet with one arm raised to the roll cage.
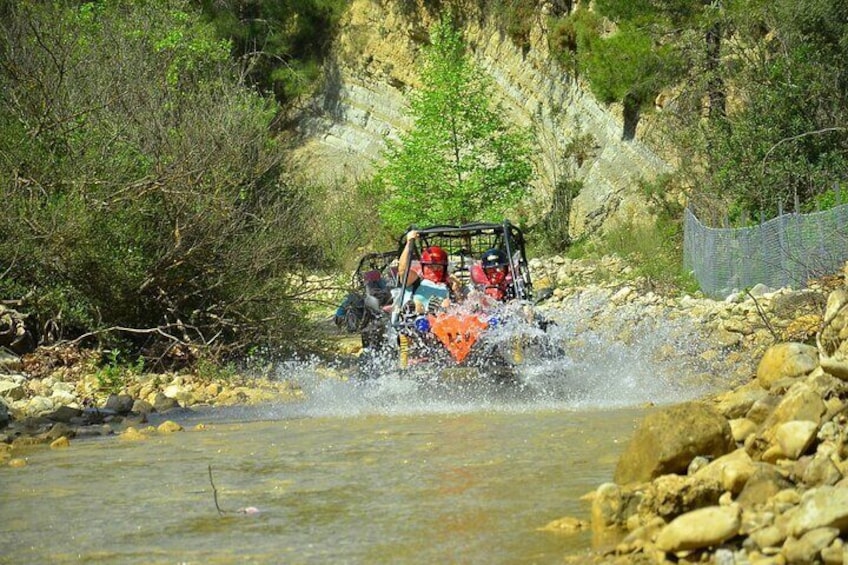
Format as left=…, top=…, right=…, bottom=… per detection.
left=398, top=230, right=461, bottom=314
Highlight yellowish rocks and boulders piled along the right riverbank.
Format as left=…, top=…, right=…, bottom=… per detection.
left=528, top=261, right=848, bottom=565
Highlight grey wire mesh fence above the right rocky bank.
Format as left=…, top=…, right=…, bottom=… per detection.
left=683, top=204, right=848, bottom=299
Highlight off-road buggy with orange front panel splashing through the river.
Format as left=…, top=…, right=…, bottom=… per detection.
left=351, top=221, right=546, bottom=380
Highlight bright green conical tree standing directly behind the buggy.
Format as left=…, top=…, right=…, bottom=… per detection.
left=371, top=15, right=533, bottom=232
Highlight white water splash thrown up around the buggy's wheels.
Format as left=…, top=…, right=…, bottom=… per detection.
left=230, top=296, right=736, bottom=418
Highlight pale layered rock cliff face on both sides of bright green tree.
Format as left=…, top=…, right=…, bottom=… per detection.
left=294, top=0, right=667, bottom=237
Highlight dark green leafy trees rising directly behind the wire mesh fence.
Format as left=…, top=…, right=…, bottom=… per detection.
left=688, top=0, right=848, bottom=223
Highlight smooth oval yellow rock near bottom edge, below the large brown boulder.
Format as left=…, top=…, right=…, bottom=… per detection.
left=656, top=506, right=740, bottom=553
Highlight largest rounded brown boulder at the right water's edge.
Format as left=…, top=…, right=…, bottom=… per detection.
left=614, top=402, right=735, bottom=484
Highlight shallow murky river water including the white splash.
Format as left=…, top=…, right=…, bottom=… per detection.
left=0, top=308, right=732, bottom=564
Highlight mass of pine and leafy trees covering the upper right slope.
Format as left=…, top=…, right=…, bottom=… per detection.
left=551, top=0, right=848, bottom=223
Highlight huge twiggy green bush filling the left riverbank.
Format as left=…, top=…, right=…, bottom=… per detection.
left=0, top=0, right=315, bottom=351
